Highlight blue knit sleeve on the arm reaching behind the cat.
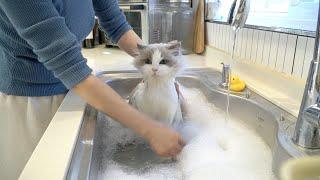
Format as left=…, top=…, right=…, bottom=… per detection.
left=93, top=0, right=132, bottom=43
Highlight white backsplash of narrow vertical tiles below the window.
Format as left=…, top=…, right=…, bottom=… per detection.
left=206, top=22, right=315, bottom=79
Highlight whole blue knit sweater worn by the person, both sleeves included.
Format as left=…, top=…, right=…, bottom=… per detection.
left=0, top=0, right=131, bottom=96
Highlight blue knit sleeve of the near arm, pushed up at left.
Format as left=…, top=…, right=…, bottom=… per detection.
left=0, top=0, right=92, bottom=89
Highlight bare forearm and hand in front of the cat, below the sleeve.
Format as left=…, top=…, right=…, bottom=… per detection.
left=73, top=75, right=184, bottom=156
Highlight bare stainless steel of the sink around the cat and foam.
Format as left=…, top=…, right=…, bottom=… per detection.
left=67, top=68, right=320, bottom=179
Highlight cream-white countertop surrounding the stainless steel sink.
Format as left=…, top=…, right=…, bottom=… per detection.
left=20, top=46, right=304, bottom=180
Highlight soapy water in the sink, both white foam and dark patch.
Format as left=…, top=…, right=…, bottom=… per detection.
left=98, top=88, right=276, bottom=180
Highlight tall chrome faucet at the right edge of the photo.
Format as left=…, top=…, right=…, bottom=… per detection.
left=292, top=2, right=320, bottom=149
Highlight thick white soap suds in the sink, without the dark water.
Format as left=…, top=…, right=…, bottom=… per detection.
left=99, top=88, right=275, bottom=180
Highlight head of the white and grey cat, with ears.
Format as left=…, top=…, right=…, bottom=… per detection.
left=134, top=41, right=184, bottom=79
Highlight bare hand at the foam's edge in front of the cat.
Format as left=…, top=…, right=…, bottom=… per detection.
left=146, top=124, right=185, bottom=157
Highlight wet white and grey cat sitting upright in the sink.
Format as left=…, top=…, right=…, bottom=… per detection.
left=129, top=41, right=184, bottom=127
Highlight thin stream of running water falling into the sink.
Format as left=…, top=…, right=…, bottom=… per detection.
left=225, top=27, right=238, bottom=125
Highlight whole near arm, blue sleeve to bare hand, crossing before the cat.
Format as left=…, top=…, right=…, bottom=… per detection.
left=0, top=0, right=185, bottom=155
